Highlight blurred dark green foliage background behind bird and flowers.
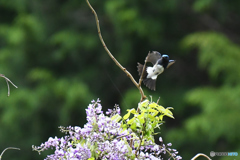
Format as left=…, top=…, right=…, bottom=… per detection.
left=0, top=0, right=240, bottom=160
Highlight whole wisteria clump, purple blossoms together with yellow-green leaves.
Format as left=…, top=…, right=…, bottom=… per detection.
left=32, top=100, right=182, bottom=160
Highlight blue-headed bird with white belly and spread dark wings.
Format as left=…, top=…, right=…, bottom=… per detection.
left=137, top=51, right=175, bottom=91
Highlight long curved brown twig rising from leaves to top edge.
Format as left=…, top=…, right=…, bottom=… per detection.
left=86, top=0, right=146, bottom=101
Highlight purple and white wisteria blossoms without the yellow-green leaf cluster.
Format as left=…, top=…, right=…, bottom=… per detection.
left=32, top=100, right=182, bottom=160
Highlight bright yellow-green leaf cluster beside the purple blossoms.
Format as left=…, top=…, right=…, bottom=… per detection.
left=122, top=99, right=174, bottom=141
